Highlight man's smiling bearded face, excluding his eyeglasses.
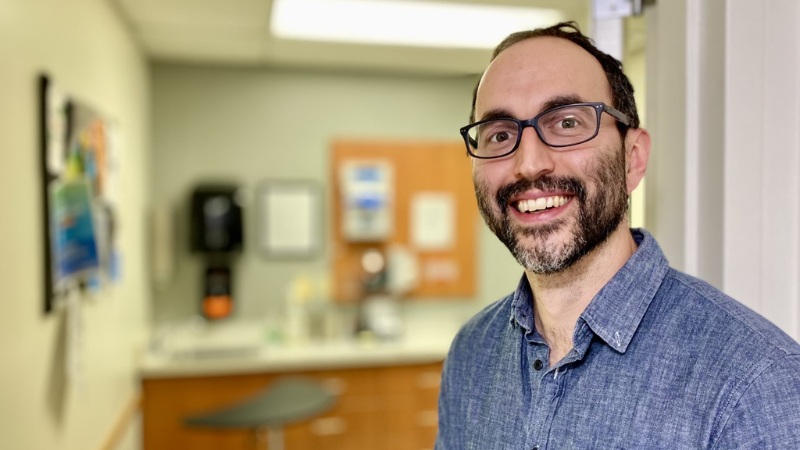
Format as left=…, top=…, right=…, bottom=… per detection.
left=472, top=37, right=629, bottom=274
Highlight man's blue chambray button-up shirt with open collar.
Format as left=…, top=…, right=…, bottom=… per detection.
left=436, top=230, right=800, bottom=450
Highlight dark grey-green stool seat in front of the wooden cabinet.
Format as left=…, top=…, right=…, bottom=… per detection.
left=185, top=378, right=335, bottom=429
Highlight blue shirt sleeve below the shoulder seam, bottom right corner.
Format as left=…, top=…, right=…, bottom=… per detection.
left=712, top=355, right=800, bottom=450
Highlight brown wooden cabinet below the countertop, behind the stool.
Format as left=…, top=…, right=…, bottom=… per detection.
left=143, top=363, right=442, bottom=450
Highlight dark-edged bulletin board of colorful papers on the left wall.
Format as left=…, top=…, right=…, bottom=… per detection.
left=41, top=76, right=121, bottom=312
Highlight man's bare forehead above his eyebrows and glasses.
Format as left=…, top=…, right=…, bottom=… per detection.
left=475, top=37, right=611, bottom=120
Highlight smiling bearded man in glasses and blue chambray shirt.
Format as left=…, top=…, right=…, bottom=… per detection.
left=436, top=23, right=800, bottom=450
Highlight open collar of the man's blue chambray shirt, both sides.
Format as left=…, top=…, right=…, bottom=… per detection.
left=510, top=229, right=669, bottom=353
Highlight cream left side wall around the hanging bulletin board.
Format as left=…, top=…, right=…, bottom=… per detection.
left=0, top=0, right=150, bottom=450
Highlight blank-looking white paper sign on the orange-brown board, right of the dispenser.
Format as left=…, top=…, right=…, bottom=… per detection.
left=411, top=192, right=456, bottom=250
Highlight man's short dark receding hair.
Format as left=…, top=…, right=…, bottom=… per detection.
left=469, top=22, right=639, bottom=138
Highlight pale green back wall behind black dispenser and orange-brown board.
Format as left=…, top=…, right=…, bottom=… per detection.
left=153, top=64, right=522, bottom=321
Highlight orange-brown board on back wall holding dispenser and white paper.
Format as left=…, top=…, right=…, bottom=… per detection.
left=330, top=140, right=478, bottom=303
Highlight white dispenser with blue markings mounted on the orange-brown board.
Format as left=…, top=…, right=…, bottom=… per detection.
left=340, top=161, right=394, bottom=242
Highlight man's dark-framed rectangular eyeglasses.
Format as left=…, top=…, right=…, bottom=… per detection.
left=461, top=102, right=630, bottom=159
